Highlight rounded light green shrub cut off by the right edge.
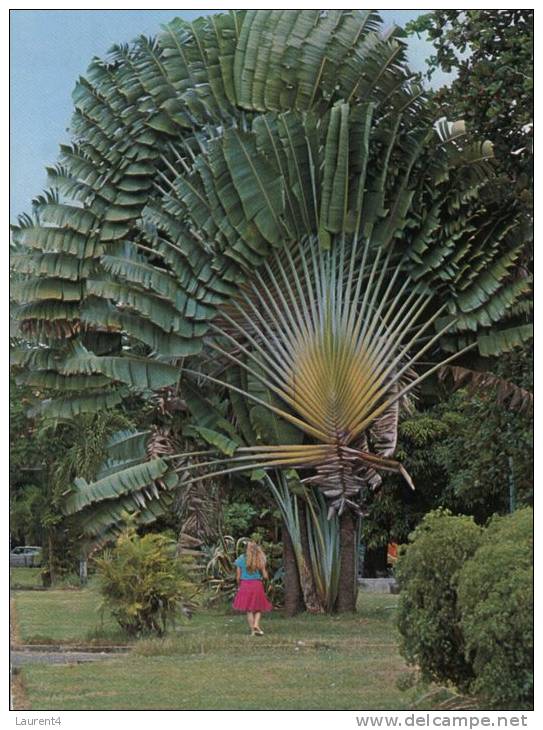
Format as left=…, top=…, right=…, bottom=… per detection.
left=458, top=508, right=534, bottom=710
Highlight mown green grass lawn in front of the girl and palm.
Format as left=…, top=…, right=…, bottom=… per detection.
left=16, top=589, right=416, bottom=710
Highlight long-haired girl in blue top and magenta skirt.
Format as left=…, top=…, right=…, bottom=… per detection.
left=232, top=542, right=272, bottom=636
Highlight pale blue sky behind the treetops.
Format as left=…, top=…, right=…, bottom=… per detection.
left=10, top=9, right=450, bottom=221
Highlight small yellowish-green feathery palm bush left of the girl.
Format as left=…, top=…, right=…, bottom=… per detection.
left=96, top=527, right=195, bottom=636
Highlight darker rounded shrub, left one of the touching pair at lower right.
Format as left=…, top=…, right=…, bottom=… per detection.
left=395, top=510, right=482, bottom=690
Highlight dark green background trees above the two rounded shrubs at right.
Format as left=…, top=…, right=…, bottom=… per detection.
left=362, top=350, right=533, bottom=564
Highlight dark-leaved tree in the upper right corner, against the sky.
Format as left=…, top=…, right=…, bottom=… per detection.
left=408, top=9, right=534, bottom=192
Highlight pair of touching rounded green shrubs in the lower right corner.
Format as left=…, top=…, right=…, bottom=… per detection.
left=396, top=508, right=533, bottom=710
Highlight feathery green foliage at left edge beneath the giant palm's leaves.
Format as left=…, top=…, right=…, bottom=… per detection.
left=10, top=373, right=139, bottom=583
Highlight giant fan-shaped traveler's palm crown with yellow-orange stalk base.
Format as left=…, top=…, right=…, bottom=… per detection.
left=13, top=10, right=530, bottom=596
